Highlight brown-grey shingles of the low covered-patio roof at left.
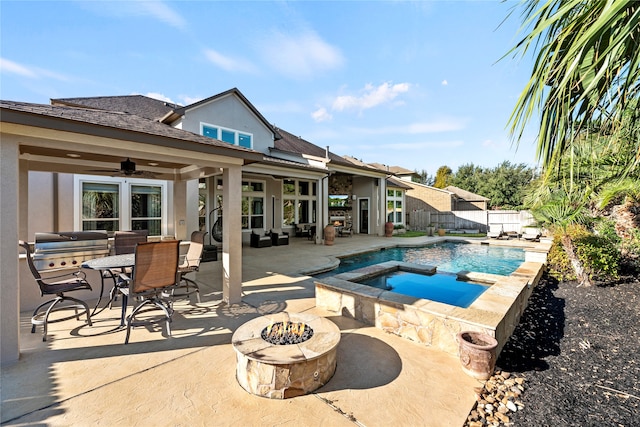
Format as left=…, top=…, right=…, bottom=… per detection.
left=0, top=100, right=261, bottom=160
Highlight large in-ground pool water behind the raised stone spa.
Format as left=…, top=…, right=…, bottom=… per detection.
left=315, top=242, right=525, bottom=278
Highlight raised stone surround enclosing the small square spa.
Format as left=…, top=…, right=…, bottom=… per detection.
left=315, top=252, right=544, bottom=355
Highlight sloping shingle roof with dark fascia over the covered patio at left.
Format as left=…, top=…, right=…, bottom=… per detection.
left=0, top=100, right=262, bottom=162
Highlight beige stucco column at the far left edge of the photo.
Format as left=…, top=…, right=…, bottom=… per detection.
left=0, top=136, right=20, bottom=364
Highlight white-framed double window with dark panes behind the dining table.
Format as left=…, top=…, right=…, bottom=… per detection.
left=74, top=175, right=167, bottom=236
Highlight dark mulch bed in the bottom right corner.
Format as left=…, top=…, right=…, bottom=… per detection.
left=496, top=276, right=640, bottom=427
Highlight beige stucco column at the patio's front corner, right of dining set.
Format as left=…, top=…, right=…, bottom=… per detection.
left=222, top=166, right=242, bottom=304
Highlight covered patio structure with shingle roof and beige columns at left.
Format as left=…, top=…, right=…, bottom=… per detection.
left=0, top=101, right=262, bottom=364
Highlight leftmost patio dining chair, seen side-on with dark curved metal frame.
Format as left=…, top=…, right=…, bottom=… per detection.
left=18, top=240, right=91, bottom=341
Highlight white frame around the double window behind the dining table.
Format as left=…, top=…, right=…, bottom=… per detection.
left=73, top=175, right=172, bottom=235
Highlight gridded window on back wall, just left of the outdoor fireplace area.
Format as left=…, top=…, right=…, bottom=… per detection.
left=282, top=179, right=317, bottom=225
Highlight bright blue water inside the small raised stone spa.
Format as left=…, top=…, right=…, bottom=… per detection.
left=360, top=271, right=489, bottom=308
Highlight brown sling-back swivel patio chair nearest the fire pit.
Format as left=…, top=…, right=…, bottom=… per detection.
left=118, top=240, right=180, bottom=344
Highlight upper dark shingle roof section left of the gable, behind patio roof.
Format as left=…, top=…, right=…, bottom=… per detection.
left=51, top=95, right=178, bottom=121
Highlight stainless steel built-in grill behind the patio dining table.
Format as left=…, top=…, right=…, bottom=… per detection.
left=33, top=230, right=109, bottom=271
